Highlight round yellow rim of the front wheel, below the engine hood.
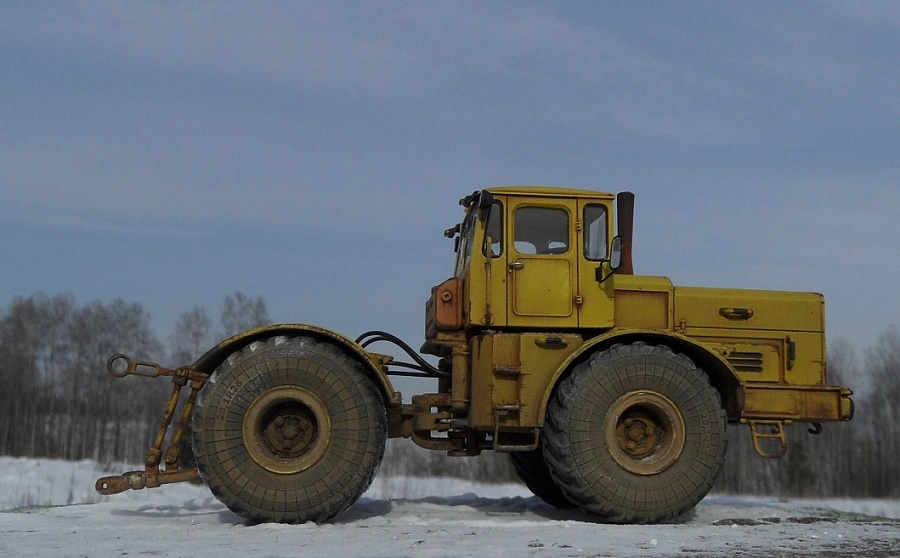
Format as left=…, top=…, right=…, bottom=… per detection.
left=605, top=391, right=685, bottom=475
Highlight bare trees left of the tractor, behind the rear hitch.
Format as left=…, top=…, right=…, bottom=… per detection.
left=0, top=292, right=269, bottom=463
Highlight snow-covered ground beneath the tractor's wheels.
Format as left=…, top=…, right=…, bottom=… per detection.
left=0, top=457, right=900, bottom=558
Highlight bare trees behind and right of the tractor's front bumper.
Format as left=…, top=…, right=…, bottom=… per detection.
left=716, top=327, right=900, bottom=498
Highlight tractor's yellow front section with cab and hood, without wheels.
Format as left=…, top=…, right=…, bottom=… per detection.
left=411, top=187, right=853, bottom=456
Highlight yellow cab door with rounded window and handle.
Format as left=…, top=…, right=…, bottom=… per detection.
left=506, top=197, right=578, bottom=328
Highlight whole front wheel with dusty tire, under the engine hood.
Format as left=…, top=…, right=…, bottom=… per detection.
left=542, top=343, right=727, bottom=523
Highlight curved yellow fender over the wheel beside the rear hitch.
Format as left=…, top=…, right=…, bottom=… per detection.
left=192, top=324, right=402, bottom=407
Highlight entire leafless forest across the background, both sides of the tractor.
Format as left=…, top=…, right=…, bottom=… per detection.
left=0, top=292, right=900, bottom=498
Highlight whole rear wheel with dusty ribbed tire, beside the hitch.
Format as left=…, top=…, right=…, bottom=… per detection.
left=192, top=337, right=387, bottom=523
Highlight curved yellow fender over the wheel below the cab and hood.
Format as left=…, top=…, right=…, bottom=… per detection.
left=538, top=329, right=744, bottom=421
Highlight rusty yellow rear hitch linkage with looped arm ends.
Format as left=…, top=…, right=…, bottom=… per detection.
left=94, top=354, right=209, bottom=496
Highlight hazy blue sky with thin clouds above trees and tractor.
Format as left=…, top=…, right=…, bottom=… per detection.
left=0, top=1, right=900, bottom=380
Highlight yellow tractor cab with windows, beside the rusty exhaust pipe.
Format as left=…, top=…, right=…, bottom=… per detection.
left=429, top=187, right=630, bottom=338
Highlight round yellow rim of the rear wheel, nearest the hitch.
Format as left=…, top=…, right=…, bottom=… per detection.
left=241, top=386, right=331, bottom=475
